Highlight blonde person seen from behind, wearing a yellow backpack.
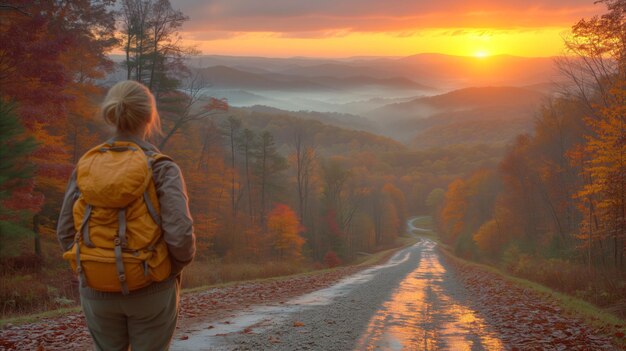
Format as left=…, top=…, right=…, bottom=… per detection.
left=57, top=81, right=195, bottom=351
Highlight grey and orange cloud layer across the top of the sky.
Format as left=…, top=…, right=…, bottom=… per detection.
left=172, top=0, right=604, bottom=37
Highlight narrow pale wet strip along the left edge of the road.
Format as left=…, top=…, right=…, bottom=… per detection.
left=170, top=241, right=425, bottom=351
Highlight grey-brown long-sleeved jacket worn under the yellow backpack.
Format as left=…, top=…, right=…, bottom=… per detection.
left=57, top=137, right=196, bottom=293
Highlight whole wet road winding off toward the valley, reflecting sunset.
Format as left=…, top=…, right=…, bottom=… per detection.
left=172, top=234, right=504, bottom=350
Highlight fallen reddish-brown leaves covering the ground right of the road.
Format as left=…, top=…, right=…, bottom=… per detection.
left=443, top=255, right=618, bottom=350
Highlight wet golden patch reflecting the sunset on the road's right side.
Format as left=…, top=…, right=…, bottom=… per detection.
left=355, top=241, right=504, bottom=350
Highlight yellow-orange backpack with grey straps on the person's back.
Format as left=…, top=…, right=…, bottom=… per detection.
left=63, top=141, right=171, bottom=295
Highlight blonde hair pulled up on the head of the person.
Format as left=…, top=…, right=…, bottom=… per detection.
left=102, top=80, right=161, bottom=136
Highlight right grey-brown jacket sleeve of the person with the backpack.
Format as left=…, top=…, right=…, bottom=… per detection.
left=153, top=160, right=196, bottom=274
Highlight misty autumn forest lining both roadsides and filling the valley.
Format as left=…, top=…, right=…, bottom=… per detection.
left=0, top=0, right=626, bottom=324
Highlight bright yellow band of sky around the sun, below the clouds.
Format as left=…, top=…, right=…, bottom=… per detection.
left=183, top=27, right=566, bottom=58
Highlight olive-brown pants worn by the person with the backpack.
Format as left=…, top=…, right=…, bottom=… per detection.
left=80, top=279, right=180, bottom=351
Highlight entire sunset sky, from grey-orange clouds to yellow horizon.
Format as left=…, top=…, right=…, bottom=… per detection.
left=171, top=0, right=605, bottom=57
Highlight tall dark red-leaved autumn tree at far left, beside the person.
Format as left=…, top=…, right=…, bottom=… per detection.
left=0, top=0, right=116, bottom=256
